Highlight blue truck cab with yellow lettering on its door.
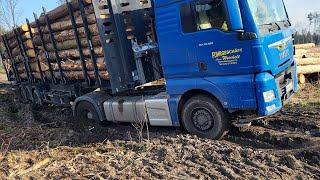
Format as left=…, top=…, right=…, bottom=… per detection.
left=150, top=0, right=298, bottom=138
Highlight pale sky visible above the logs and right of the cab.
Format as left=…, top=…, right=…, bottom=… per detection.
left=16, top=0, right=320, bottom=30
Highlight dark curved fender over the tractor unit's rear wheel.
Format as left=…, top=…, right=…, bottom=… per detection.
left=72, top=91, right=111, bottom=121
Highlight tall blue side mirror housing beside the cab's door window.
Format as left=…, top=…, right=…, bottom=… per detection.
left=224, top=0, right=243, bottom=31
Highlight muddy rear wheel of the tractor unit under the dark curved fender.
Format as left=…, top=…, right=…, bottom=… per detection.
left=76, top=101, right=109, bottom=126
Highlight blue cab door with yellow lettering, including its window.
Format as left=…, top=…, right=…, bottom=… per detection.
left=182, top=0, right=253, bottom=76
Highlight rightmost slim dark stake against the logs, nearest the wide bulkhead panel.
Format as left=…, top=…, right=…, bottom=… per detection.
left=78, top=0, right=102, bottom=86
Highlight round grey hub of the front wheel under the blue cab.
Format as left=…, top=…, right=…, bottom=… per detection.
left=192, top=108, right=214, bottom=131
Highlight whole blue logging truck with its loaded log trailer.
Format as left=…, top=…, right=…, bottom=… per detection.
left=0, top=0, right=298, bottom=139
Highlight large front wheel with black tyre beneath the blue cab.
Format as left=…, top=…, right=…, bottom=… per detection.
left=181, top=95, right=231, bottom=140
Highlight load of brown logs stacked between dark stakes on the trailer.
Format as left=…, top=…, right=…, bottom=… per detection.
left=0, top=0, right=109, bottom=80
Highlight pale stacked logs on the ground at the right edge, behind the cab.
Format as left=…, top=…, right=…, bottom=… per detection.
left=295, top=43, right=320, bottom=84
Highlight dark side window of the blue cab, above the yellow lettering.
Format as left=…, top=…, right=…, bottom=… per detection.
left=181, top=0, right=228, bottom=32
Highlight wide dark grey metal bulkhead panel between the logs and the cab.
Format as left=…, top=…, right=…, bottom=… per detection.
left=92, top=0, right=133, bottom=94
